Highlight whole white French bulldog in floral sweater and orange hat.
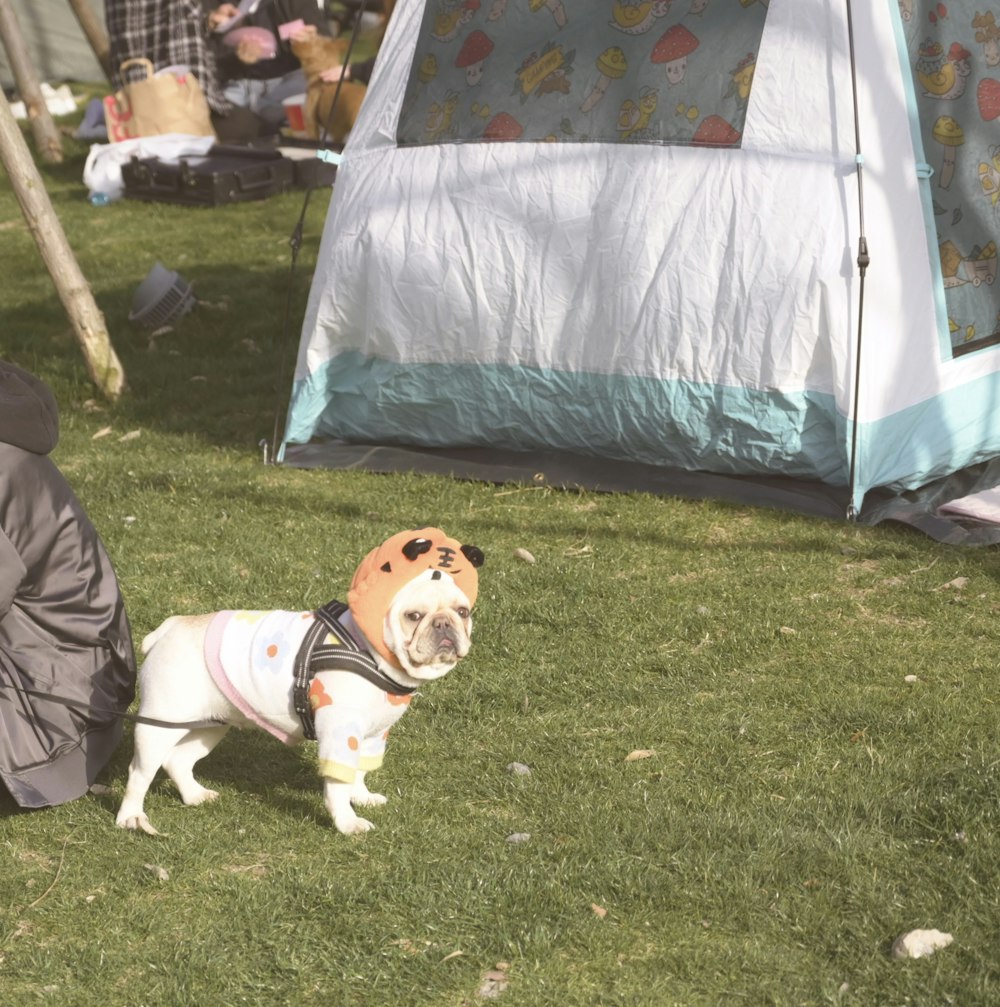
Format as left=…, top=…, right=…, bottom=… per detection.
left=117, top=528, right=482, bottom=834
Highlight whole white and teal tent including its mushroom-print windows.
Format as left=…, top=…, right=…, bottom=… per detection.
left=283, top=0, right=1000, bottom=527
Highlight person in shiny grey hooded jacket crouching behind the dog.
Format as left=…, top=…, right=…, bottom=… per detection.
left=0, top=361, right=136, bottom=808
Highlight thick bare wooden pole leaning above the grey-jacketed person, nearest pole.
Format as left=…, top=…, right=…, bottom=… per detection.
left=0, top=87, right=125, bottom=402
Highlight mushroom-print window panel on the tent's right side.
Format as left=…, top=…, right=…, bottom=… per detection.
left=899, top=0, right=1000, bottom=356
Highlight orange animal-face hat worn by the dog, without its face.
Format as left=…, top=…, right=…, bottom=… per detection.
left=347, top=528, right=483, bottom=668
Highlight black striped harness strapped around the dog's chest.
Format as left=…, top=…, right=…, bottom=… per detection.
left=292, top=601, right=417, bottom=740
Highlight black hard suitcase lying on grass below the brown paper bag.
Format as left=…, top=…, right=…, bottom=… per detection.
left=122, top=144, right=295, bottom=206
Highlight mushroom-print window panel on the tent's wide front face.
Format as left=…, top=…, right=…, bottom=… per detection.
left=396, top=0, right=768, bottom=147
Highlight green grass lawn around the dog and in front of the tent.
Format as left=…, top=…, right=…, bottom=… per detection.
left=0, top=104, right=1000, bottom=1007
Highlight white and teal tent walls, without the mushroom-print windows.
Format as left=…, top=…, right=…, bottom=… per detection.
left=286, top=0, right=1000, bottom=519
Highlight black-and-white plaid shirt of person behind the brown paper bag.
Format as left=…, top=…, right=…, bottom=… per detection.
left=105, top=0, right=232, bottom=115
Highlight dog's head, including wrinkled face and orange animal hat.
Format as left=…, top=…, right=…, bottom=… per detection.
left=347, top=528, right=482, bottom=681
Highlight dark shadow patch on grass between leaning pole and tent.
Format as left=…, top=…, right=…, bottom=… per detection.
left=3, top=260, right=311, bottom=447
